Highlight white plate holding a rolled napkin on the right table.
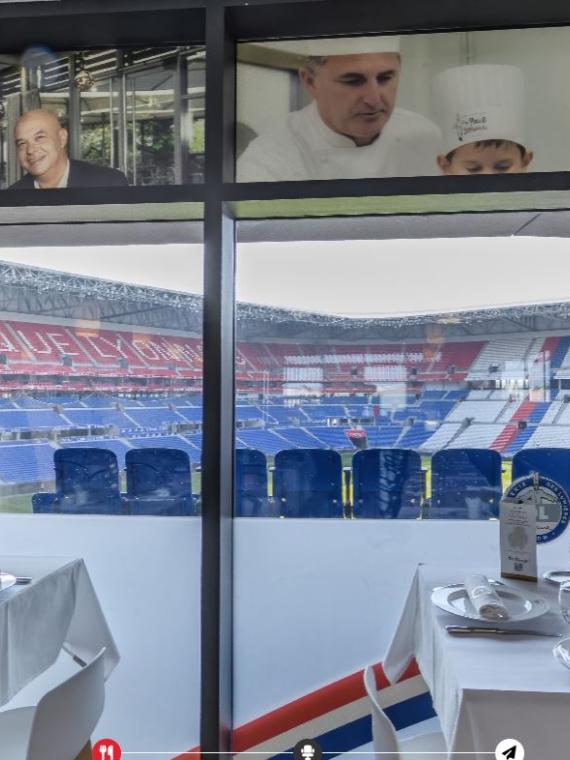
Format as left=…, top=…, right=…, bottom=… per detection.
left=431, top=580, right=548, bottom=625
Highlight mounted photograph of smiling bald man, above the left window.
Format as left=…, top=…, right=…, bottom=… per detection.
left=0, top=45, right=205, bottom=190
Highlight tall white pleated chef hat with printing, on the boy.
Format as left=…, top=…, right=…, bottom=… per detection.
left=434, top=64, right=525, bottom=155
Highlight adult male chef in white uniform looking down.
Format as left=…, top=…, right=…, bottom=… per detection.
left=237, top=36, right=440, bottom=182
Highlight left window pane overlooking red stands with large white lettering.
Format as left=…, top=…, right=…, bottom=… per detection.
left=0, top=239, right=203, bottom=758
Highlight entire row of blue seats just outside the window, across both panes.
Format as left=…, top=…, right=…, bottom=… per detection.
left=32, top=448, right=570, bottom=519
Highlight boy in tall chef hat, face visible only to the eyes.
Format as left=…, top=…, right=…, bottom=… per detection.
left=434, top=64, right=533, bottom=175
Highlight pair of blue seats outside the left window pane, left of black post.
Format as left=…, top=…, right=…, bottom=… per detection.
left=32, top=448, right=197, bottom=515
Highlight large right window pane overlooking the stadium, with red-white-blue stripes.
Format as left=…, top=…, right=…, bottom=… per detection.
left=233, top=235, right=570, bottom=756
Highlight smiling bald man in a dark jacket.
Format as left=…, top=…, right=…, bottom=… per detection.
left=10, top=109, right=128, bottom=190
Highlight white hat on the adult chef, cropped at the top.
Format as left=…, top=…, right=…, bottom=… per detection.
left=266, top=34, right=400, bottom=58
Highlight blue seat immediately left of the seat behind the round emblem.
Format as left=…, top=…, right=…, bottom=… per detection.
left=427, top=449, right=496, bottom=520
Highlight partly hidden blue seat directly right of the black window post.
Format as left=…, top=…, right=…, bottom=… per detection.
left=235, top=449, right=278, bottom=517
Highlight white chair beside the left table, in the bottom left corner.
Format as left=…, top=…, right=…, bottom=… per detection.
left=0, top=648, right=105, bottom=760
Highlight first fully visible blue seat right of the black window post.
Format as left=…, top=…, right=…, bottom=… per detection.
left=273, top=449, right=343, bottom=517
